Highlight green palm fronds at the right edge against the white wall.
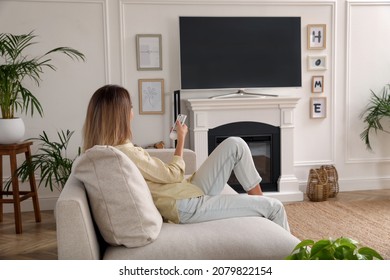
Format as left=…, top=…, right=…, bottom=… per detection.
left=360, top=84, right=390, bottom=150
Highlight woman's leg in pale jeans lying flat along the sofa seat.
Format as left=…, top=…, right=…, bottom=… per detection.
left=177, top=194, right=290, bottom=231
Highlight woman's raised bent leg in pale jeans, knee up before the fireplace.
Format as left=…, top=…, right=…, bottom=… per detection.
left=191, top=137, right=261, bottom=195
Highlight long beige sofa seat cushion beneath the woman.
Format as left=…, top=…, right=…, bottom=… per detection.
left=103, top=217, right=300, bottom=260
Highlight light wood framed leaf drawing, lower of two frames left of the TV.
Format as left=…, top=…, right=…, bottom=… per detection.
left=138, top=79, right=164, bottom=114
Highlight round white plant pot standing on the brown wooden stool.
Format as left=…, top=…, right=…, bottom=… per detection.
left=0, top=118, right=25, bottom=144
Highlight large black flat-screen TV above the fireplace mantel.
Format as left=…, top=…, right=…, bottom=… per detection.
left=179, top=17, right=301, bottom=89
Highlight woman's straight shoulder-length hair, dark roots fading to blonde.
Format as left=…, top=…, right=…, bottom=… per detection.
left=83, top=85, right=133, bottom=151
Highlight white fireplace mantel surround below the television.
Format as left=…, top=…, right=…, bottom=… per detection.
left=186, top=96, right=303, bottom=201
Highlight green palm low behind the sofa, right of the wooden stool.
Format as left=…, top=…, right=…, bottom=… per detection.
left=5, top=130, right=80, bottom=191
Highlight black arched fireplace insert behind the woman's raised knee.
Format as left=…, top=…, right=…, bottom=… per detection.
left=208, top=122, right=280, bottom=193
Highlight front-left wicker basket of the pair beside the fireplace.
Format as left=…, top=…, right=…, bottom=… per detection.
left=306, top=167, right=329, bottom=201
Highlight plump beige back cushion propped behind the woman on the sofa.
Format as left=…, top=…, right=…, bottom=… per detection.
left=73, top=145, right=162, bottom=247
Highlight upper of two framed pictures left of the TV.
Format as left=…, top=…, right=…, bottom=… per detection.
left=136, top=34, right=162, bottom=70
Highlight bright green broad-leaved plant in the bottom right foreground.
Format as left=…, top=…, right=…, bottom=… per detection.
left=286, top=237, right=383, bottom=260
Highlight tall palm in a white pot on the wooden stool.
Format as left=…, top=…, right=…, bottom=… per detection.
left=0, top=32, right=85, bottom=144
